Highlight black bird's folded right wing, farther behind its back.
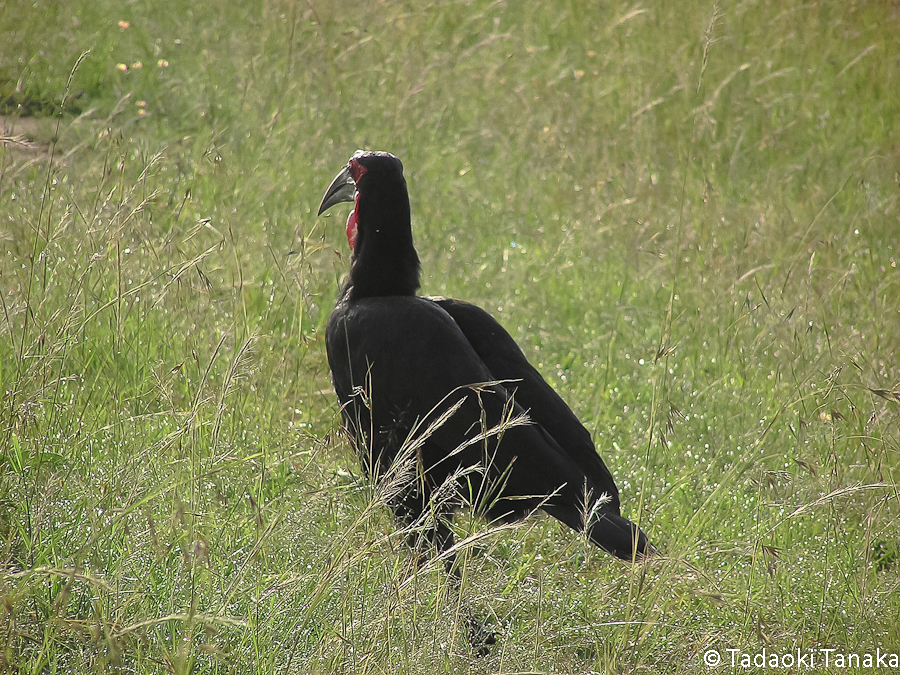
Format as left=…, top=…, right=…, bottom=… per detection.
left=429, top=297, right=619, bottom=512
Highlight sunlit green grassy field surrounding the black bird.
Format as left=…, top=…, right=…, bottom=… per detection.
left=0, top=0, right=900, bottom=674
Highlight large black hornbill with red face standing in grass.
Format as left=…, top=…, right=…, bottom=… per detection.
left=319, top=151, right=652, bottom=564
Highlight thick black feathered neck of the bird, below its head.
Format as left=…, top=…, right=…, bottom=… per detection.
left=348, top=185, right=419, bottom=300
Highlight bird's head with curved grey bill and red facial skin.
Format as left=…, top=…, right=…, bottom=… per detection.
left=317, top=150, right=406, bottom=251
